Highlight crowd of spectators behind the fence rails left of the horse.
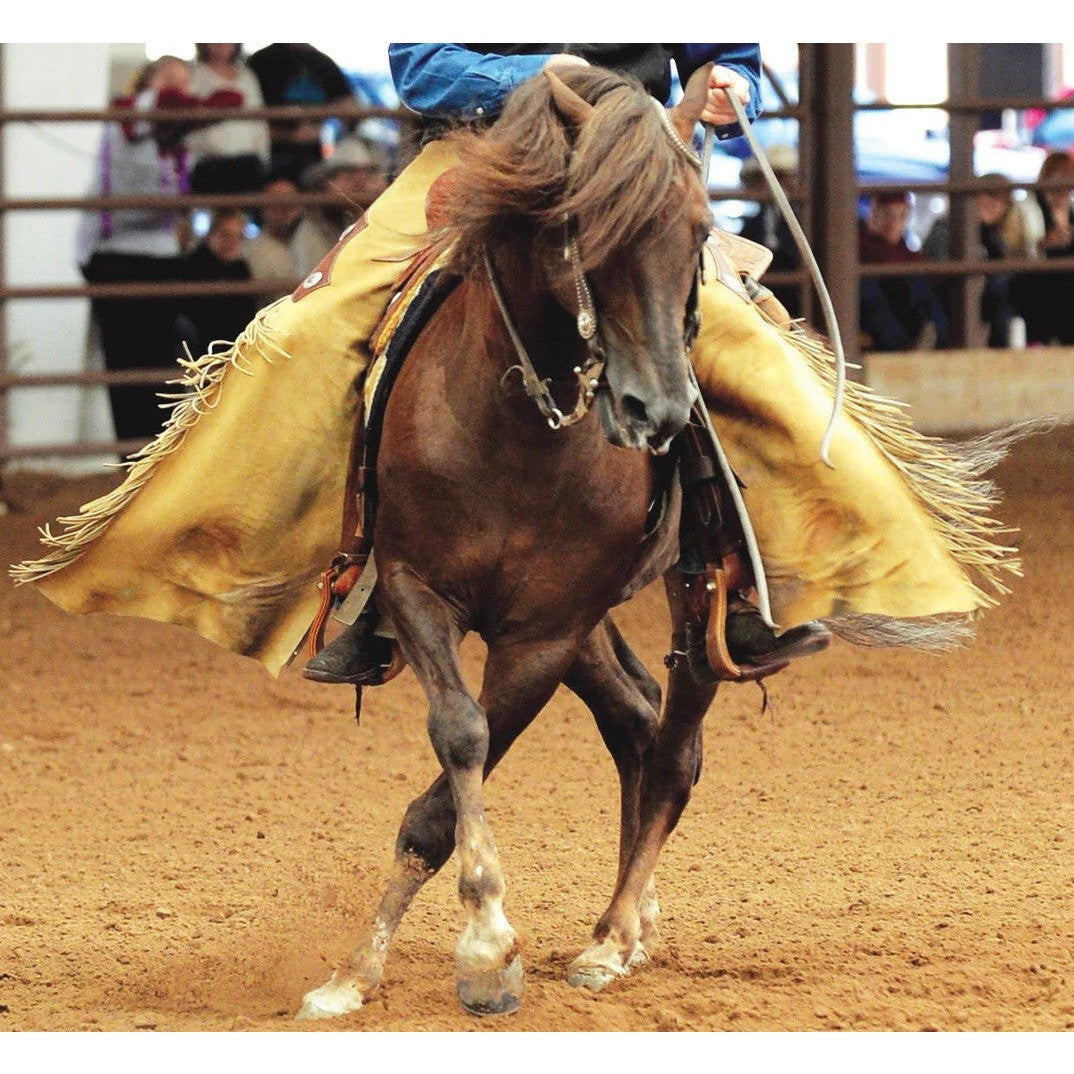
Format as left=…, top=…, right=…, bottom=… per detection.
left=76, top=44, right=388, bottom=440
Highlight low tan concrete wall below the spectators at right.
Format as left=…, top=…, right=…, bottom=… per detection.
left=865, top=347, right=1074, bottom=434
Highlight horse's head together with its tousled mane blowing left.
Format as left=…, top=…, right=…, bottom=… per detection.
left=444, top=66, right=712, bottom=453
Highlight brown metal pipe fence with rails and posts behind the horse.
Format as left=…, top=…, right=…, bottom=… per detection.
left=0, top=45, right=1074, bottom=466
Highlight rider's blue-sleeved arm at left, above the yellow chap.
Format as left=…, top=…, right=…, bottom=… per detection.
left=388, top=42, right=550, bottom=119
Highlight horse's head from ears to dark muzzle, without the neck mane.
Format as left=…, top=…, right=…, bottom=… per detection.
left=548, top=68, right=712, bottom=453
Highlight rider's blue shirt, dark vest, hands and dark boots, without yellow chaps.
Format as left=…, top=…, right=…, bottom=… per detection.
left=305, top=43, right=818, bottom=684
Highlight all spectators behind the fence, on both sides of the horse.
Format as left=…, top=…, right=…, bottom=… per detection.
left=77, top=43, right=1074, bottom=439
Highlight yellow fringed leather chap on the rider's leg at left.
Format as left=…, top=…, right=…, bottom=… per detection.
left=20, top=143, right=454, bottom=672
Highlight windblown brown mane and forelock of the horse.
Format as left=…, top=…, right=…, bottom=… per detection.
left=445, top=66, right=690, bottom=271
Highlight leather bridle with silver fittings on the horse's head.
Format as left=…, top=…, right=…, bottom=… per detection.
left=481, top=99, right=705, bottom=430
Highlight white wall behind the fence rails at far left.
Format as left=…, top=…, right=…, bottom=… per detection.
left=0, top=44, right=113, bottom=468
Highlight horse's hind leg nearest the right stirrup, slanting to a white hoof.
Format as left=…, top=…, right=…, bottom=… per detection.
left=569, top=569, right=715, bottom=989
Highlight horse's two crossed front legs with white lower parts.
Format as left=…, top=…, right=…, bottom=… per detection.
left=317, top=567, right=578, bottom=1014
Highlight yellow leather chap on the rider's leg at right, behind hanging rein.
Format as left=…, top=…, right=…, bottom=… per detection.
left=691, top=259, right=974, bottom=637
